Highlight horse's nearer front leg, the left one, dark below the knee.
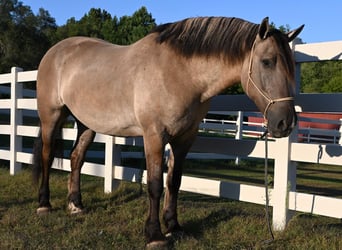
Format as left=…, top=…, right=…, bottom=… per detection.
left=144, top=135, right=166, bottom=247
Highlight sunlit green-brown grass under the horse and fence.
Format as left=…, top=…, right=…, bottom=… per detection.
left=0, top=161, right=342, bottom=249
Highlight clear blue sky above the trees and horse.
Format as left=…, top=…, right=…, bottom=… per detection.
left=21, top=0, right=342, bottom=43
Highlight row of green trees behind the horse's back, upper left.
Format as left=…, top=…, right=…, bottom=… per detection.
left=0, top=0, right=156, bottom=73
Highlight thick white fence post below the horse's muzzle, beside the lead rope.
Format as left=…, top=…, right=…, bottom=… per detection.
left=271, top=127, right=298, bottom=231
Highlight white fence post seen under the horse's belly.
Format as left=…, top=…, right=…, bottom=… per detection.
left=104, top=135, right=121, bottom=193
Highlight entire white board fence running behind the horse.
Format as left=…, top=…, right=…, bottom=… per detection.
left=0, top=41, right=342, bottom=230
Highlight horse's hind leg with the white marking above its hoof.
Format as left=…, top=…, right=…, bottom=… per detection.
left=68, top=121, right=95, bottom=214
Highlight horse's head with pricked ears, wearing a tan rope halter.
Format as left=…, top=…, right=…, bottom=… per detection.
left=241, top=18, right=304, bottom=137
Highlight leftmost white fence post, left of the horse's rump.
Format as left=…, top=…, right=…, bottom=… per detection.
left=10, top=67, right=23, bottom=175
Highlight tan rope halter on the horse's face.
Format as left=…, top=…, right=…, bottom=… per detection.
left=246, top=40, right=294, bottom=127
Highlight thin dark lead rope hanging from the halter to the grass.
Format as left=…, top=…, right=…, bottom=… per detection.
left=261, top=127, right=274, bottom=244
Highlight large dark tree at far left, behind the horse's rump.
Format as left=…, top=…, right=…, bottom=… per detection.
left=0, top=0, right=56, bottom=72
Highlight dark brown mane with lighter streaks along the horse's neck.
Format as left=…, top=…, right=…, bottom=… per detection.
left=152, top=17, right=259, bottom=61
